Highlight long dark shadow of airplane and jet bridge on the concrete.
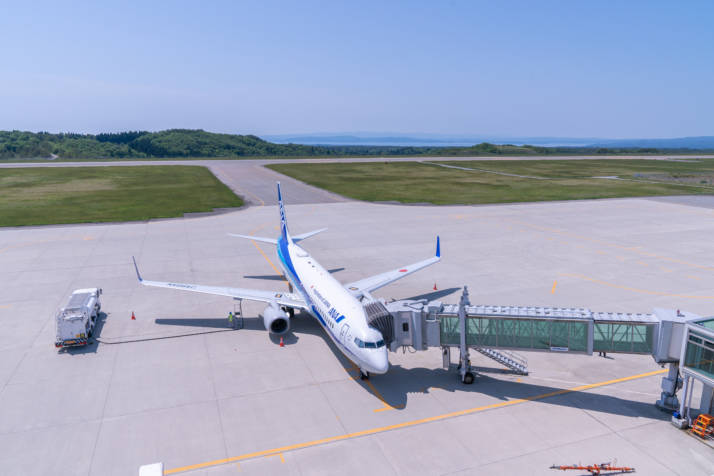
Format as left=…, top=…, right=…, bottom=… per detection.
left=156, top=310, right=668, bottom=420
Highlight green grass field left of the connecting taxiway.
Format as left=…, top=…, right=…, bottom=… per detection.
left=0, top=166, right=243, bottom=226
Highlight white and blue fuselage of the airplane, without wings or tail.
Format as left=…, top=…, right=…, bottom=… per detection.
left=277, top=238, right=389, bottom=374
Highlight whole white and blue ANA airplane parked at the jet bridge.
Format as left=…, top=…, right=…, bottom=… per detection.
left=132, top=182, right=441, bottom=379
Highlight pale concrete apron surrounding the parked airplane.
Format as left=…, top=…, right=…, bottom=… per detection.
left=0, top=164, right=714, bottom=475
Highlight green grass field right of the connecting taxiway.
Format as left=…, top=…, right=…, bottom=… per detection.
left=268, top=159, right=714, bottom=204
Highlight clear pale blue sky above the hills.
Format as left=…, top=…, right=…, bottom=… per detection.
left=0, top=0, right=714, bottom=138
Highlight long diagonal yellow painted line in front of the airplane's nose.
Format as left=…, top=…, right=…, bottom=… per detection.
left=164, top=370, right=667, bottom=474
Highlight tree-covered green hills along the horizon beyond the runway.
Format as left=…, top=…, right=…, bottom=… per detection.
left=0, top=129, right=703, bottom=160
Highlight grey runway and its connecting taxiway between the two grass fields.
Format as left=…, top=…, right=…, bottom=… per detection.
left=0, top=155, right=714, bottom=205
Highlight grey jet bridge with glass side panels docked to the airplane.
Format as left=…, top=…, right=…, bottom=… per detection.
left=378, top=287, right=714, bottom=410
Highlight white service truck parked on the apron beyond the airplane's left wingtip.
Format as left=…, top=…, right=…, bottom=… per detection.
left=55, top=288, right=102, bottom=349
